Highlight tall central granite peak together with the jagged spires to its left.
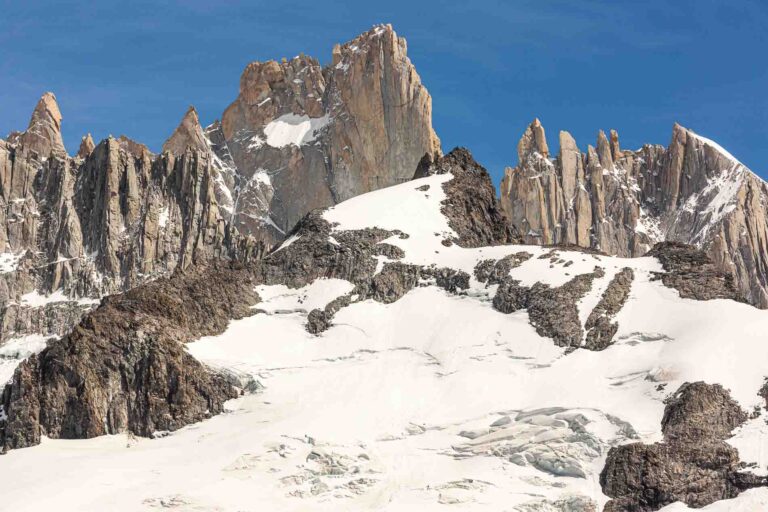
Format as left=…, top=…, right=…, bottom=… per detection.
left=0, top=25, right=440, bottom=352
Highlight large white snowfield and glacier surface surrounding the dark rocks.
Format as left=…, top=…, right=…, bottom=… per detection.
left=0, top=175, right=768, bottom=512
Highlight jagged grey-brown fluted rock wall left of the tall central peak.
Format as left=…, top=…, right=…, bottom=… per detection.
left=0, top=94, right=264, bottom=343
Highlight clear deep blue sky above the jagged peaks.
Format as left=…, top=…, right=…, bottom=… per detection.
left=0, top=0, right=768, bottom=184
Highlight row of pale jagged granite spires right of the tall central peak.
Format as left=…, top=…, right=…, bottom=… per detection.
left=501, top=120, right=768, bottom=308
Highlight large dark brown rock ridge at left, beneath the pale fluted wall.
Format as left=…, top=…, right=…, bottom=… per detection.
left=0, top=267, right=258, bottom=449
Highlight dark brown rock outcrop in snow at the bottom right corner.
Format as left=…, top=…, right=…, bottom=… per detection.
left=600, top=382, right=768, bottom=512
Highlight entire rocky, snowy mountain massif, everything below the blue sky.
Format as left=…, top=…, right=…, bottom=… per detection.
left=0, top=25, right=768, bottom=512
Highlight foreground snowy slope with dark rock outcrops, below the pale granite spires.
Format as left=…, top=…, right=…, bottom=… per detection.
left=0, top=150, right=768, bottom=512
